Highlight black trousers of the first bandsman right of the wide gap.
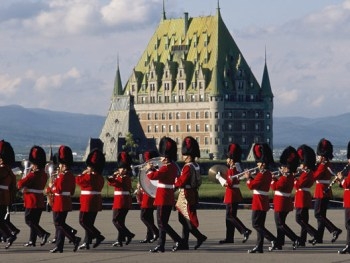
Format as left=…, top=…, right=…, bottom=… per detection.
left=225, top=203, right=248, bottom=242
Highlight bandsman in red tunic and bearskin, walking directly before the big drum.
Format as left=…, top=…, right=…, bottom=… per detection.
left=146, top=137, right=182, bottom=253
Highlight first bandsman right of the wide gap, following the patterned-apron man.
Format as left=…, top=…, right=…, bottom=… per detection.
left=219, top=143, right=252, bottom=244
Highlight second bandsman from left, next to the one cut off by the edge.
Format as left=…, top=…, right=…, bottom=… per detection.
left=17, top=145, right=50, bottom=247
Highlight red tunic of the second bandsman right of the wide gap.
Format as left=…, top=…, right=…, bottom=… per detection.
left=247, top=170, right=272, bottom=211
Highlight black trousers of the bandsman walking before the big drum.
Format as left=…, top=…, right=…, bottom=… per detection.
left=157, top=205, right=181, bottom=250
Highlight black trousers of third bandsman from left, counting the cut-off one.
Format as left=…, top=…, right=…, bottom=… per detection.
left=52, top=211, right=75, bottom=250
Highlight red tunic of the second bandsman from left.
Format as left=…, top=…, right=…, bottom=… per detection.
left=17, top=169, right=47, bottom=208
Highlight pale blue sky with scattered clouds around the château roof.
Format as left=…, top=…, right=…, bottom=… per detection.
left=0, top=0, right=350, bottom=118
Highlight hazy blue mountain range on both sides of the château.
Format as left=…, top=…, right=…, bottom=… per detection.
left=0, top=105, right=350, bottom=160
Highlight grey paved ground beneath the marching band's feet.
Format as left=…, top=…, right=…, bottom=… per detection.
left=0, top=209, right=350, bottom=263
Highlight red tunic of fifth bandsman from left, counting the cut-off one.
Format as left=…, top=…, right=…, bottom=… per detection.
left=108, top=175, right=132, bottom=209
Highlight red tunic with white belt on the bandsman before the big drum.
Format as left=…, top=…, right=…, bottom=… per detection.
left=147, top=163, right=178, bottom=206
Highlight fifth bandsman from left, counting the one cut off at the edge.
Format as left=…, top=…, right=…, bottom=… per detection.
left=108, top=152, right=135, bottom=247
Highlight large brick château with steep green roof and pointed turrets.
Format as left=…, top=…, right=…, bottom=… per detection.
left=89, top=5, right=273, bottom=160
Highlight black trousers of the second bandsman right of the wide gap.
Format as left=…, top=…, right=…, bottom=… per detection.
left=252, top=210, right=276, bottom=249
